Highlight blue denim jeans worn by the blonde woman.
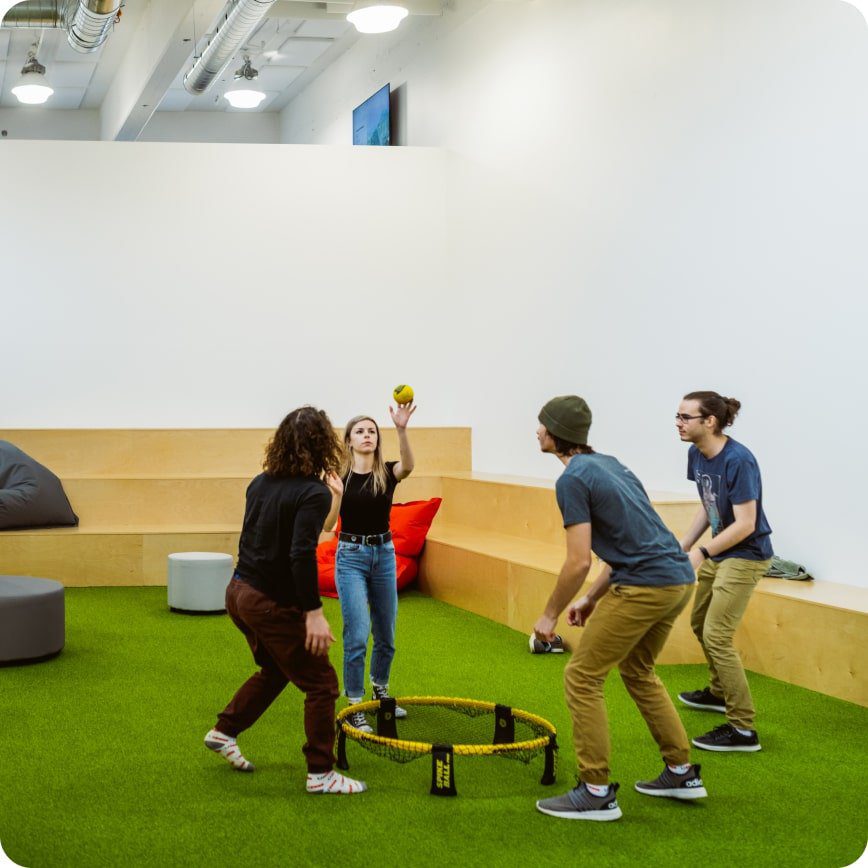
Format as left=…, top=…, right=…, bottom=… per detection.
left=335, top=542, right=398, bottom=699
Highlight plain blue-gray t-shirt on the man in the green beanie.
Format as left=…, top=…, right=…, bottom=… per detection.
left=555, top=453, right=696, bottom=586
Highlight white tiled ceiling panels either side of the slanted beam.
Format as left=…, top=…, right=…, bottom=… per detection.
left=0, top=0, right=359, bottom=112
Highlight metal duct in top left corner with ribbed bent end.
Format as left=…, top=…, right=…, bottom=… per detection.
left=0, top=0, right=121, bottom=54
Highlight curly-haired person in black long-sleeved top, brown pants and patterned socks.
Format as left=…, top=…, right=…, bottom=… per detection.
left=205, top=407, right=367, bottom=794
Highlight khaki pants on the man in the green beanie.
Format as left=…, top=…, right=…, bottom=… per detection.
left=564, top=584, right=693, bottom=785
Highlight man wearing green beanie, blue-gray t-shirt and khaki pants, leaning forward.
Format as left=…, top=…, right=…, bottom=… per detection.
left=534, top=395, right=707, bottom=821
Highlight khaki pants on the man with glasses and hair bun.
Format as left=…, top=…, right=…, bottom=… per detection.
left=690, top=558, right=771, bottom=729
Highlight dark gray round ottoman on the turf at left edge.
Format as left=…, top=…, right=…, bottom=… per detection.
left=0, top=576, right=66, bottom=665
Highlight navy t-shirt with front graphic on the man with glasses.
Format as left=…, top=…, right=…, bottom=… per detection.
left=687, top=437, right=773, bottom=561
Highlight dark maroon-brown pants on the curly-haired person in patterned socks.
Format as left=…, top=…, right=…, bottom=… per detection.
left=217, top=579, right=338, bottom=772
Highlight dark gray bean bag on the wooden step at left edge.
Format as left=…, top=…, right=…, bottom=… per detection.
left=0, top=440, right=78, bottom=530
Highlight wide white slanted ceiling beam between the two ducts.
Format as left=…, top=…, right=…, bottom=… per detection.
left=100, top=0, right=225, bottom=141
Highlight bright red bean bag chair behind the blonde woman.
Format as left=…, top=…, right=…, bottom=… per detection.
left=316, top=497, right=442, bottom=597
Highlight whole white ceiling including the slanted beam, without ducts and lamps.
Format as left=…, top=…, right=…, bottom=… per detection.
left=0, top=0, right=446, bottom=140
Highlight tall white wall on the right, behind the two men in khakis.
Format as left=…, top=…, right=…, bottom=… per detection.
left=282, top=0, right=868, bottom=585
